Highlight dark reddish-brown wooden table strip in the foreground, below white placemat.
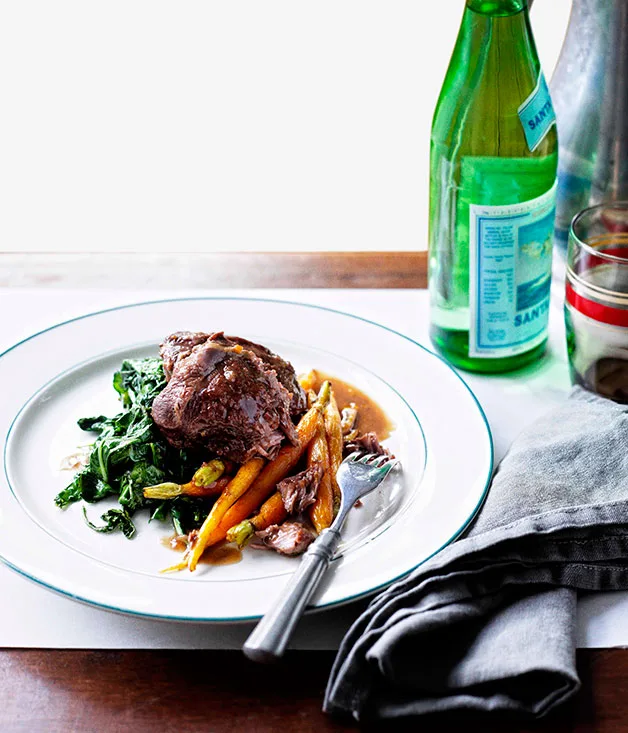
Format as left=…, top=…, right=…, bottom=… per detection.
left=0, top=650, right=628, bottom=733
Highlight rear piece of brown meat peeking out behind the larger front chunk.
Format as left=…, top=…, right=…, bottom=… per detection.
left=160, top=331, right=307, bottom=417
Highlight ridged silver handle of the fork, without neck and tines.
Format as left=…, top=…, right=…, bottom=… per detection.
left=242, top=529, right=340, bottom=662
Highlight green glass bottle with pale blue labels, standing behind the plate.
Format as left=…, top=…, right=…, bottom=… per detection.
left=429, top=0, right=558, bottom=372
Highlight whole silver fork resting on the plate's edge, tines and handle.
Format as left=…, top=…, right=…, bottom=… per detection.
left=243, top=453, right=397, bottom=662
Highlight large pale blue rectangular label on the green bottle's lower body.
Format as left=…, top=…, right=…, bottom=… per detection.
left=469, top=184, right=556, bottom=358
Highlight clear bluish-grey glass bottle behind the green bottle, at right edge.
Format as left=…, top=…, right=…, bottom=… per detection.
left=551, top=0, right=628, bottom=255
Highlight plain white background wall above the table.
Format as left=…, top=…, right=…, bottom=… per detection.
left=0, top=0, right=570, bottom=252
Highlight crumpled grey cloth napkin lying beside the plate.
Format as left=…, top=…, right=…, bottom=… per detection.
left=324, top=388, right=628, bottom=720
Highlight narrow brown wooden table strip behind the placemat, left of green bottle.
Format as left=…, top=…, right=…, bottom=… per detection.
left=0, top=252, right=427, bottom=289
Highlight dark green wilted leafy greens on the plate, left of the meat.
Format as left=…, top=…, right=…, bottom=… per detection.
left=55, top=358, right=207, bottom=538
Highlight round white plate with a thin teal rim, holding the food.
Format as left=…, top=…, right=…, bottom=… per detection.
left=0, top=298, right=493, bottom=621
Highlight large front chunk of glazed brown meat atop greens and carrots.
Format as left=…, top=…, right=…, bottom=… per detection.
left=152, top=334, right=298, bottom=463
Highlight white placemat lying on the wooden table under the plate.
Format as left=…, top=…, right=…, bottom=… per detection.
left=0, top=289, right=628, bottom=649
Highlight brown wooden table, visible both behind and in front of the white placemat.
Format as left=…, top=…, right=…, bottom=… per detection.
left=0, top=253, right=628, bottom=733
